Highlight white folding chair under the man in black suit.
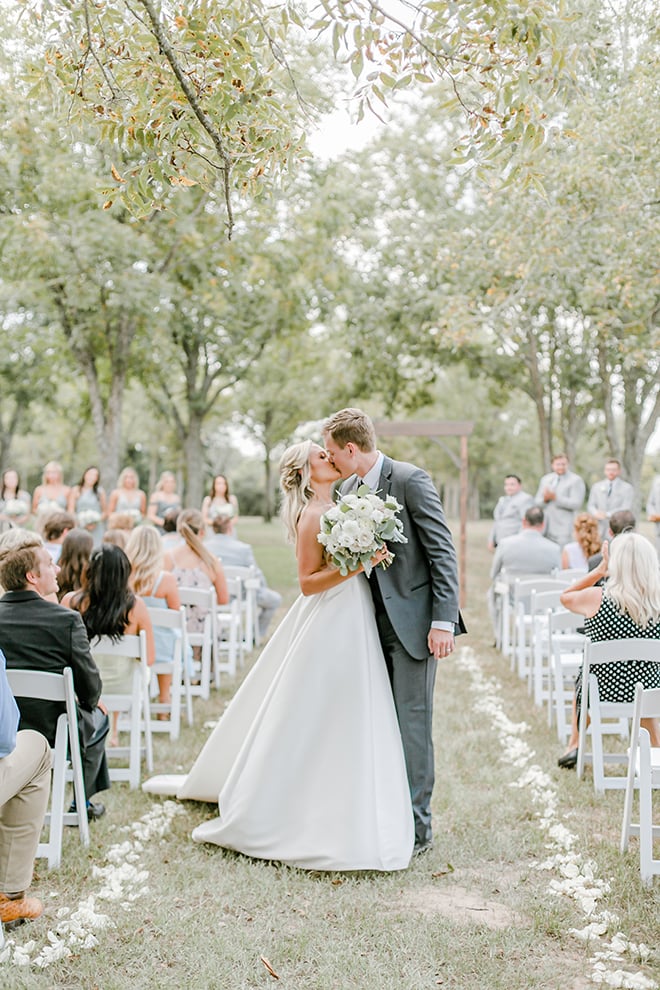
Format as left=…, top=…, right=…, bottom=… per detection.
left=7, top=667, right=89, bottom=869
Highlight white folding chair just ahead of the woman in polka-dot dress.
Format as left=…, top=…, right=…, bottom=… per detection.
left=548, top=612, right=585, bottom=746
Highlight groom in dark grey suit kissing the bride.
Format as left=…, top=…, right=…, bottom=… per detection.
left=323, top=409, right=465, bottom=853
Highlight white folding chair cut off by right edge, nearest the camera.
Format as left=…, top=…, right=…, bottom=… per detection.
left=621, top=684, right=660, bottom=883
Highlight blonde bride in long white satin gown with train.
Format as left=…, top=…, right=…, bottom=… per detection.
left=144, top=441, right=414, bottom=870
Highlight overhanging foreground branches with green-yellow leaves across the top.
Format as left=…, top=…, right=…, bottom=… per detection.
left=15, top=0, right=577, bottom=228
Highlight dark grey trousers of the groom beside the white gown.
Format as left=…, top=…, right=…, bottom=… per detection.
left=369, top=572, right=438, bottom=846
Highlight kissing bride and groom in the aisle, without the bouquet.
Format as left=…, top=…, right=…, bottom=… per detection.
left=143, top=408, right=465, bottom=870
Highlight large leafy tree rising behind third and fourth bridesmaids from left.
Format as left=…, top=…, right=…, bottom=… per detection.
left=1, top=98, right=158, bottom=483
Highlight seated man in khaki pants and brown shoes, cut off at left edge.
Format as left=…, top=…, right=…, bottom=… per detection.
left=0, top=650, right=51, bottom=941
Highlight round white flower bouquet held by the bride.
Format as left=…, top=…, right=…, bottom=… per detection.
left=317, top=485, right=408, bottom=577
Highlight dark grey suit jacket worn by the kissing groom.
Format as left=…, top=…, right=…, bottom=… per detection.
left=342, top=457, right=465, bottom=660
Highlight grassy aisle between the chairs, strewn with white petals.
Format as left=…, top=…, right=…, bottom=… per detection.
left=0, top=520, right=660, bottom=990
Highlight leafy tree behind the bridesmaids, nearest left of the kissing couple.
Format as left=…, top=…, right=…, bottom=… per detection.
left=145, top=195, right=314, bottom=504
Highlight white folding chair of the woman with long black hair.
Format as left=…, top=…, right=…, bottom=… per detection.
left=90, top=629, right=153, bottom=789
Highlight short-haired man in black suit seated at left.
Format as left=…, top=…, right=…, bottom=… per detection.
left=0, top=533, right=110, bottom=819
